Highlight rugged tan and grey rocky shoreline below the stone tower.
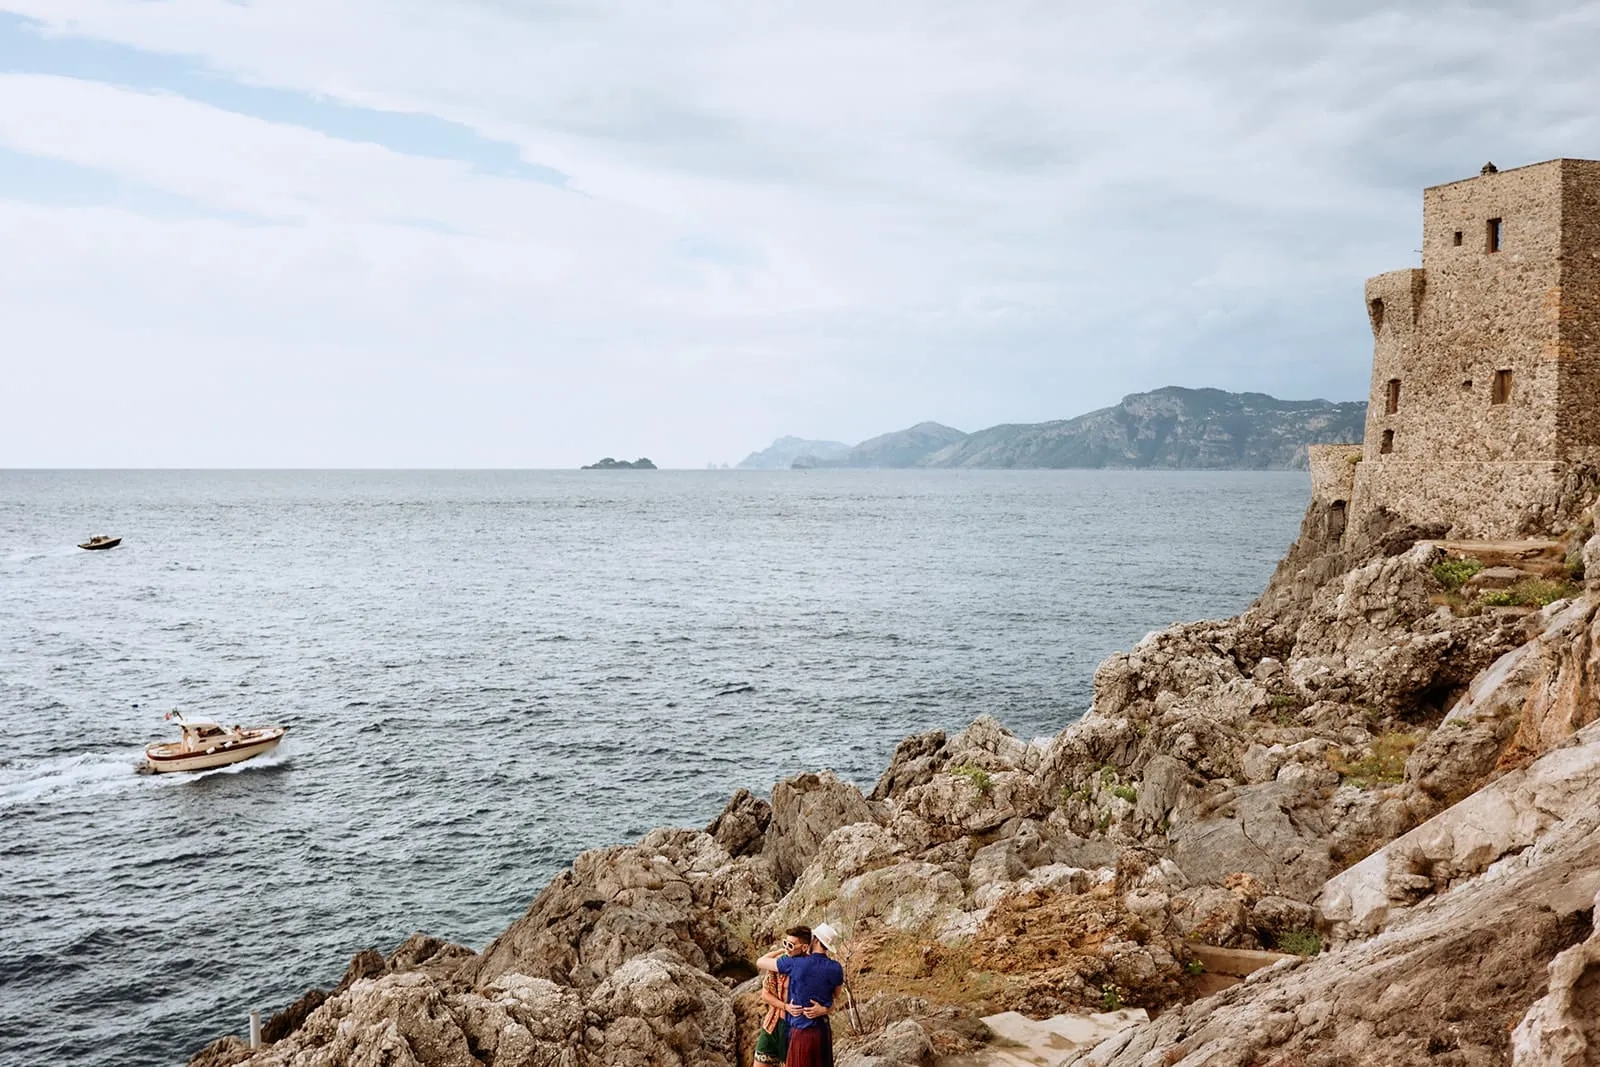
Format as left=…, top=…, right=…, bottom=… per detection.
left=190, top=472, right=1600, bottom=1067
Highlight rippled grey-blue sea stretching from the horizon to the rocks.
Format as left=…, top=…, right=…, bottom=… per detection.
left=0, top=470, right=1309, bottom=1067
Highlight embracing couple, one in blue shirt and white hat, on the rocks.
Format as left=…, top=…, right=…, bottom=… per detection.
left=755, top=923, right=845, bottom=1067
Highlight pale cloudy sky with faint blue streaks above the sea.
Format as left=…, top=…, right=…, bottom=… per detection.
left=0, top=0, right=1600, bottom=467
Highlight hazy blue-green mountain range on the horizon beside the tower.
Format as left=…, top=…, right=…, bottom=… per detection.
left=739, top=386, right=1366, bottom=470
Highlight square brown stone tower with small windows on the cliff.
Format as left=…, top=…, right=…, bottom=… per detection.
left=1314, top=160, right=1600, bottom=537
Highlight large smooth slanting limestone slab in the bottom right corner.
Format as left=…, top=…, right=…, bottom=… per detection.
left=1066, top=796, right=1600, bottom=1067
